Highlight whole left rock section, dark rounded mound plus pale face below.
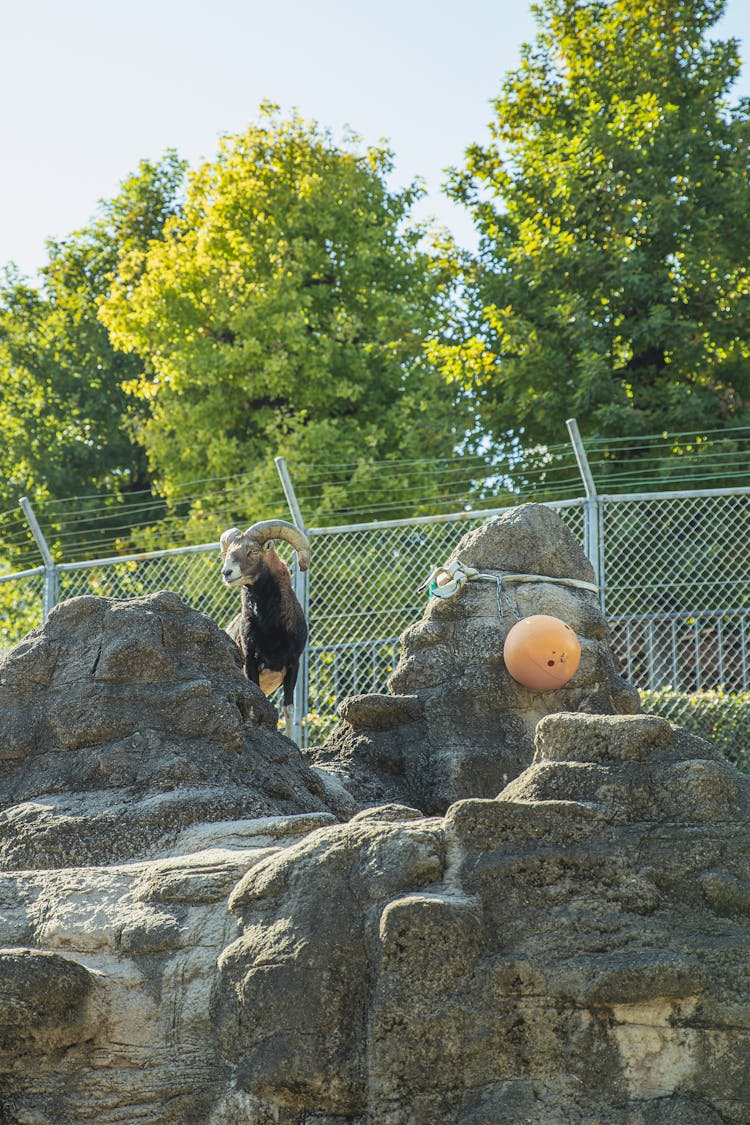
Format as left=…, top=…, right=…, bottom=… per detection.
left=0, top=592, right=334, bottom=1125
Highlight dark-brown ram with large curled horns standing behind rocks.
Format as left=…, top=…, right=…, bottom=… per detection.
left=220, top=520, right=310, bottom=738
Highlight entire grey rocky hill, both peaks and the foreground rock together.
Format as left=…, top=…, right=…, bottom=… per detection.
left=0, top=506, right=750, bottom=1125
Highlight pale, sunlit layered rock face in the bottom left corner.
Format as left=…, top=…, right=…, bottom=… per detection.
left=0, top=812, right=333, bottom=1125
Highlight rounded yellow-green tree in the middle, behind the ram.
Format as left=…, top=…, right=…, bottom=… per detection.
left=101, top=105, right=470, bottom=519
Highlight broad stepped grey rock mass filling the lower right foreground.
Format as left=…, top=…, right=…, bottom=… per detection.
left=217, top=713, right=750, bottom=1125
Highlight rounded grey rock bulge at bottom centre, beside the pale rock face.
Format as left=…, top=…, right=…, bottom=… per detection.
left=217, top=810, right=444, bottom=1119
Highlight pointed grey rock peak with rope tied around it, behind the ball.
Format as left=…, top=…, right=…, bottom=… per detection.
left=308, top=504, right=639, bottom=815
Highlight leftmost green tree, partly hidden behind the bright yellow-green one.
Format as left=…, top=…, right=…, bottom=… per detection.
left=0, top=153, right=184, bottom=560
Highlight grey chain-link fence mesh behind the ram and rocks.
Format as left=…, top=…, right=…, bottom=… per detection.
left=0, top=488, right=750, bottom=759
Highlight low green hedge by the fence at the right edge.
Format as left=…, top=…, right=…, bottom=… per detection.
left=641, top=687, right=750, bottom=771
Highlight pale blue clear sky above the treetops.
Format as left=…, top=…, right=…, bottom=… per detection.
left=0, top=0, right=750, bottom=276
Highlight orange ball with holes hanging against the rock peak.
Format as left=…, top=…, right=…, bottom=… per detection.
left=503, top=613, right=580, bottom=692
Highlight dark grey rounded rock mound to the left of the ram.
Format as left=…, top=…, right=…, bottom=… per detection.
left=0, top=593, right=327, bottom=867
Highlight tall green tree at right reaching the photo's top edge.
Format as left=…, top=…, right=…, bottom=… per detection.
left=432, top=0, right=750, bottom=461
